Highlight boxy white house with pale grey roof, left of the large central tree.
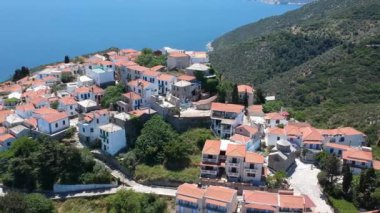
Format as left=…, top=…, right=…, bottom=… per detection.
left=99, top=123, right=127, bottom=155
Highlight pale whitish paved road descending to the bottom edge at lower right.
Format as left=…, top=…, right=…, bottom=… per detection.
left=289, top=159, right=333, bottom=213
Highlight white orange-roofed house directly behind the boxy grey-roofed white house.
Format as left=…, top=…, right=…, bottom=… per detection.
left=77, top=109, right=110, bottom=143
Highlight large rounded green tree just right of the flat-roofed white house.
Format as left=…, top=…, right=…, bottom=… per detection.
left=135, top=115, right=178, bottom=164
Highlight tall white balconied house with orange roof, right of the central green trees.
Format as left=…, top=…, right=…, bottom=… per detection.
left=211, top=103, right=244, bottom=138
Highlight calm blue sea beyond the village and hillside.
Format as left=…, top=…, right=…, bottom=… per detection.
left=0, top=0, right=299, bottom=80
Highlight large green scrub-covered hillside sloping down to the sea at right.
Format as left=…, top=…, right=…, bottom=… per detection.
left=210, top=0, right=380, bottom=143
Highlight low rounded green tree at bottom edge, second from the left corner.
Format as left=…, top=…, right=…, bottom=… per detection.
left=24, top=193, right=55, bottom=213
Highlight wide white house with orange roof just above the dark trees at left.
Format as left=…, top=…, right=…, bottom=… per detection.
left=37, top=112, right=70, bottom=135
